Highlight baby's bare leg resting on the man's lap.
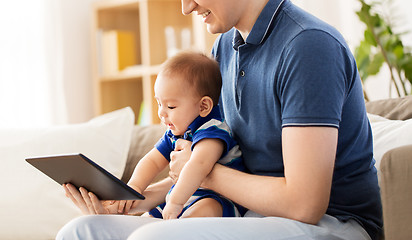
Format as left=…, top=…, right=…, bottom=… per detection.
left=181, top=198, right=223, bottom=218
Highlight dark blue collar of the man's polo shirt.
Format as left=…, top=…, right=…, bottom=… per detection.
left=233, top=0, right=289, bottom=50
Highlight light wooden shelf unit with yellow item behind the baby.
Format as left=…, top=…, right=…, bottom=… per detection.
left=92, top=0, right=216, bottom=123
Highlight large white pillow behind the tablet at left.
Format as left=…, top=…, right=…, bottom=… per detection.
left=0, top=108, right=134, bottom=239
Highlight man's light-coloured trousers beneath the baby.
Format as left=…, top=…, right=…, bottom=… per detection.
left=56, top=213, right=370, bottom=240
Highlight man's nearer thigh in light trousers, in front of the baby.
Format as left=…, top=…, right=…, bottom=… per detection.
left=128, top=215, right=370, bottom=240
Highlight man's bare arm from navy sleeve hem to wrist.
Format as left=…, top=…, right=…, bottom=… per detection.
left=172, top=127, right=338, bottom=224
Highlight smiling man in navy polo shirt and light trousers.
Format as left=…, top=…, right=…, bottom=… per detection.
left=56, top=0, right=382, bottom=239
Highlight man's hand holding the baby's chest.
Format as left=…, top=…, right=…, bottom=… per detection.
left=169, top=139, right=192, bottom=183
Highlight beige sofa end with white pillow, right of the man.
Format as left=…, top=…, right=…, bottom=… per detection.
left=366, top=96, right=412, bottom=240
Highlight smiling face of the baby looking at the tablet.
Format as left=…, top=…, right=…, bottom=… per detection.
left=154, top=73, right=201, bottom=136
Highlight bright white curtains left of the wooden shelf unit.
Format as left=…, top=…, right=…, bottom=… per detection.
left=0, top=0, right=98, bottom=127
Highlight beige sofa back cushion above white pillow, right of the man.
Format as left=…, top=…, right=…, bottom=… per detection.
left=366, top=96, right=412, bottom=120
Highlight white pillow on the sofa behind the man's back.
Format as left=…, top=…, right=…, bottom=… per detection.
left=368, top=113, right=412, bottom=169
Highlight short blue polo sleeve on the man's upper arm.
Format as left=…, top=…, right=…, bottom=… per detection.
left=277, top=30, right=352, bottom=128
